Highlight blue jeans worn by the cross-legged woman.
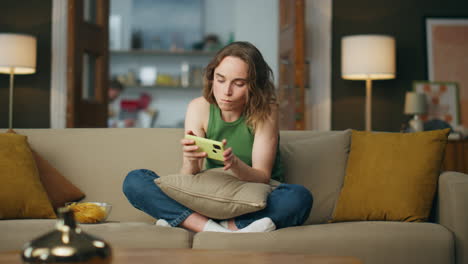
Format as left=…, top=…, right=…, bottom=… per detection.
left=123, top=169, right=313, bottom=229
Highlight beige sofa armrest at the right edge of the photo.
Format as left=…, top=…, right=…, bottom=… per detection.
left=436, top=171, right=468, bottom=264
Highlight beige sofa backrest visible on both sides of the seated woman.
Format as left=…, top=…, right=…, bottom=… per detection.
left=16, top=128, right=350, bottom=223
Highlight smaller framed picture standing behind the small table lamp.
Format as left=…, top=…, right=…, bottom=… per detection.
left=413, top=81, right=460, bottom=128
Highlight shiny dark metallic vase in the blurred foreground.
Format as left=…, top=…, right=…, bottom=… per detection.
left=21, top=207, right=112, bottom=264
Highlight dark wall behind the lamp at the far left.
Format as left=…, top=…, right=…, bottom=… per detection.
left=0, top=0, right=52, bottom=128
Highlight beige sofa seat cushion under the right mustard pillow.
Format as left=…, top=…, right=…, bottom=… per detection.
left=193, top=222, right=454, bottom=264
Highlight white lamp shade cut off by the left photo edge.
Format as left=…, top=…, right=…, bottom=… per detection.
left=0, top=33, right=36, bottom=74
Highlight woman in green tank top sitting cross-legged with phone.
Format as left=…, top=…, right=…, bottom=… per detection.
left=123, top=42, right=313, bottom=232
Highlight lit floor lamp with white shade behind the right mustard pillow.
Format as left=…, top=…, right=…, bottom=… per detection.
left=341, top=35, right=395, bottom=131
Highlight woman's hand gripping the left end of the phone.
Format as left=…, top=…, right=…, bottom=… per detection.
left=180, top=130, right=207, bottom=174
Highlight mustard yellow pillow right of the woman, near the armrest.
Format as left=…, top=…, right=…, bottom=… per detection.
left=332, top=129, right=449, bottom=222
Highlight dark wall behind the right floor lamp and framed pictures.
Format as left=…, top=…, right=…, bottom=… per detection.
left=332, top=0, right=468, bottom=131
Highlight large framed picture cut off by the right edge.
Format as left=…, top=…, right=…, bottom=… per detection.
left=425, top=17, right=468, bottom=128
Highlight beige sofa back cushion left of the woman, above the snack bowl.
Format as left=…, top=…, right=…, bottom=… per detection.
left=15, top=128, right=183, bottom=222
